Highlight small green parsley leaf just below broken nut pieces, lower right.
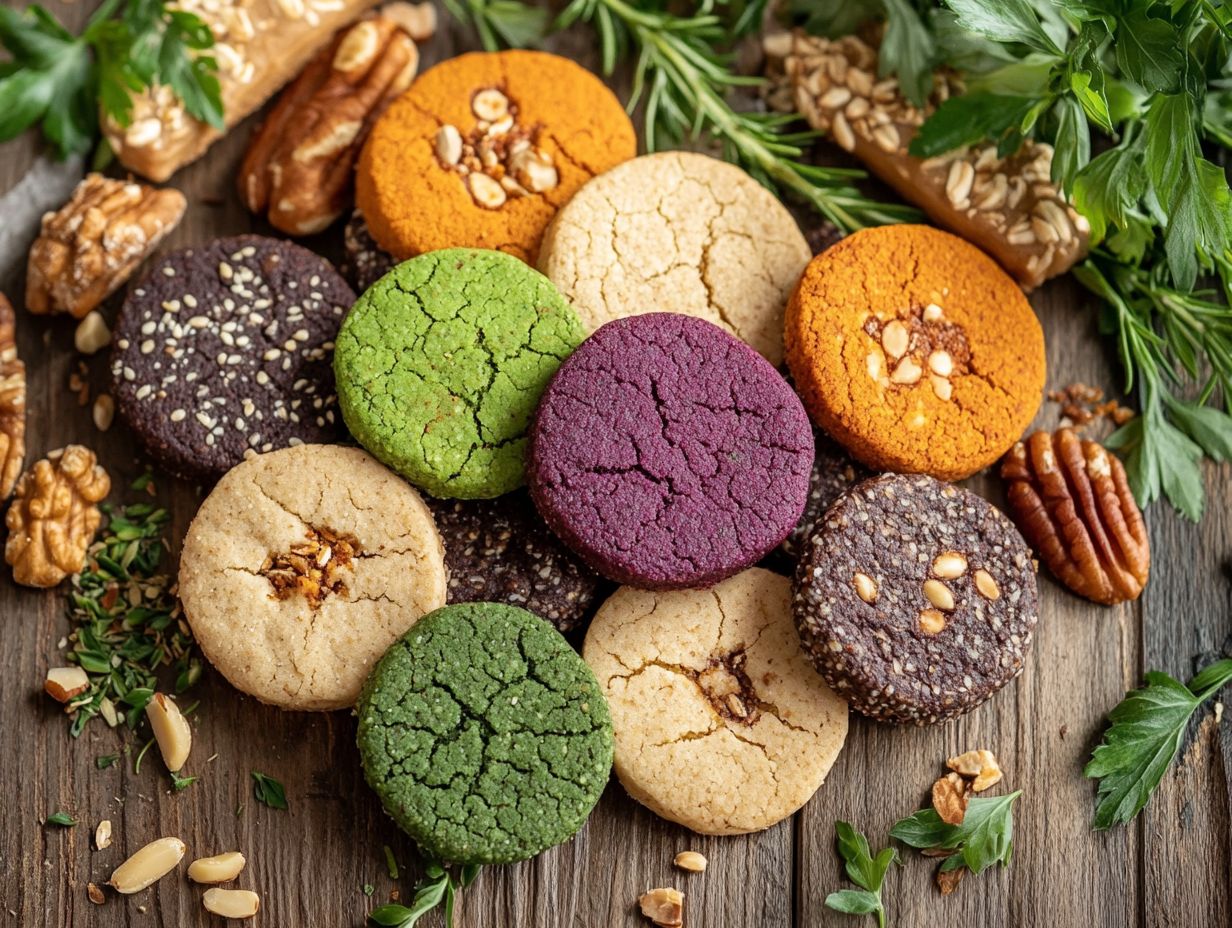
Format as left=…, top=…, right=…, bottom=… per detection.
left=890, top=790, right=1023, bottom=874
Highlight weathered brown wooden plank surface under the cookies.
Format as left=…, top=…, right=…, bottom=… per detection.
left=0, top=0, right=1232, bottom=928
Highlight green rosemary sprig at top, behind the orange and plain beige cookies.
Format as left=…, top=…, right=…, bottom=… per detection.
left=447, top=0, right=919, bottom=232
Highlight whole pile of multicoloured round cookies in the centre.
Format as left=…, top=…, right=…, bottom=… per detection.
left=91, top=52, right=1044, bottom=864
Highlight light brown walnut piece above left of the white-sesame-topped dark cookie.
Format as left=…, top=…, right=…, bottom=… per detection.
left=26, top=174, right=187, bottom=319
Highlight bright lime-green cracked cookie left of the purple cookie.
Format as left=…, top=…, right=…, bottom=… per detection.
left=334, top=248, right=585, bottom=499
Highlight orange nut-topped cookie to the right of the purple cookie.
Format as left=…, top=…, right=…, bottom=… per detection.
left=784, top=226, right=1045, bottom=479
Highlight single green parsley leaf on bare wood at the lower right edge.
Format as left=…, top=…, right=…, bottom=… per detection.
left=1083, top=661, right=1232, bottom=829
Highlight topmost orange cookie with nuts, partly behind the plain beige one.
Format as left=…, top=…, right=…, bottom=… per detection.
left=356, top=51, right=637, bottom=264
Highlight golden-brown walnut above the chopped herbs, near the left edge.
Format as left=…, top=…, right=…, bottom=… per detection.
left=4, top=445, right=111, bottom=588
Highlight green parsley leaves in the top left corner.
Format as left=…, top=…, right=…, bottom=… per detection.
left=0, top=0, right=223, bottom=157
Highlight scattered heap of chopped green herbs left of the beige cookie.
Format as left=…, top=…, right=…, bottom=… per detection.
left=65, top=478, right=202, bottom=737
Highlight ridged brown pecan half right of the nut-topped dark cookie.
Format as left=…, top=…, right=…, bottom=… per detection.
left=1002, top=429, right=1151, bottom=604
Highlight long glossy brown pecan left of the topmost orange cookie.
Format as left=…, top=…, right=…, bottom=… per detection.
left=239, top=16, right=419, bottom=235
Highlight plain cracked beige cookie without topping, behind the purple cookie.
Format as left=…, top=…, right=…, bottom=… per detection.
left=538, top=152, right=812, bottom=365
